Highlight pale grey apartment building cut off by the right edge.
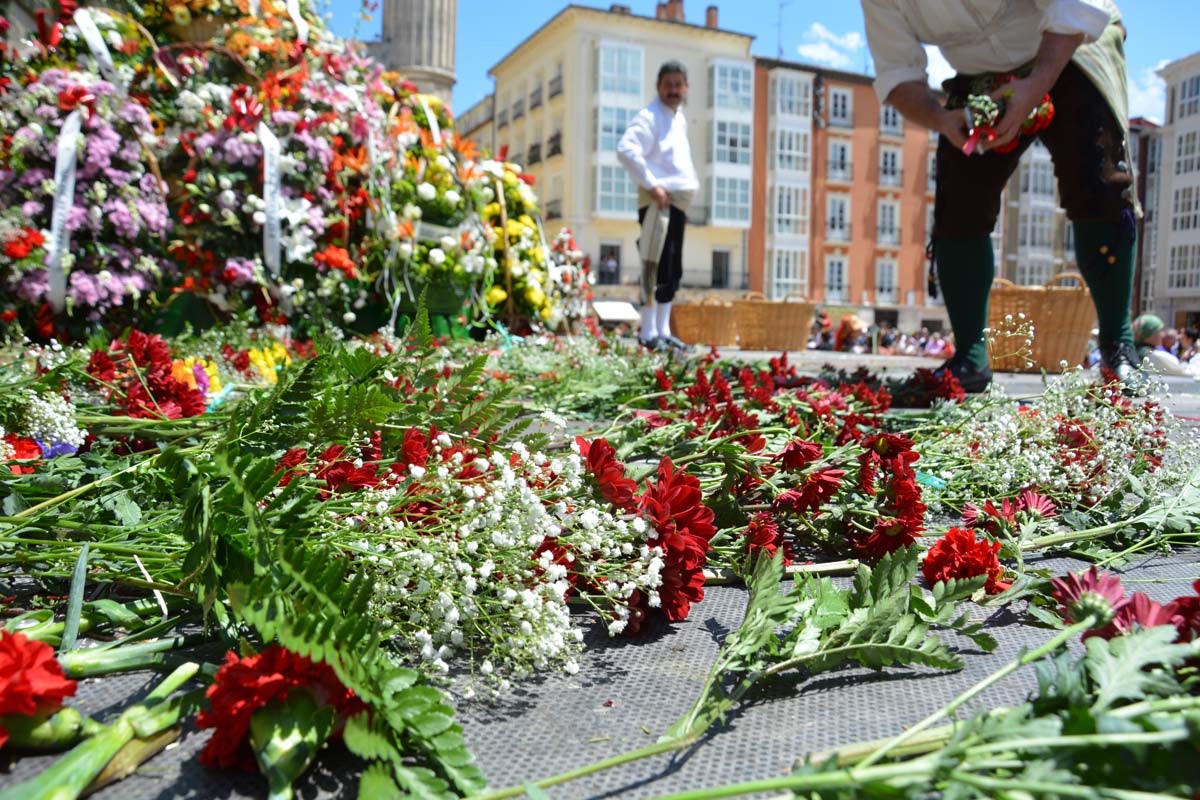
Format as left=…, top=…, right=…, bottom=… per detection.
left=1147, top=52, right=1200, bottom=327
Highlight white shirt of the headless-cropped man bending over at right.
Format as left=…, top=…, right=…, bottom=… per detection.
left=862, top=0, right=1120, bottom=102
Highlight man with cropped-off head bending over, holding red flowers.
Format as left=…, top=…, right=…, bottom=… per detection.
left=862, top=0, right=1140, bottom=392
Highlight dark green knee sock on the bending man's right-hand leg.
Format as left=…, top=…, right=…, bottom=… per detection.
left=1074, top=222, right=1138, bottom=344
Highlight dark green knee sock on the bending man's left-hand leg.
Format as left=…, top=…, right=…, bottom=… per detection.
left=934, top=236, right=996, bottom=368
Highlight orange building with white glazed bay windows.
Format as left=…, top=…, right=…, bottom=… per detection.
left=748, top=59, right=946, bottom=330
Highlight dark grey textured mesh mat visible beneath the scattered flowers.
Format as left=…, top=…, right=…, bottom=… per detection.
left=0, top=551, right=1200, bottom=800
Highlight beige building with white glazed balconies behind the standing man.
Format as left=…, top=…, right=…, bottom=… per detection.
left=482, top=0, right=755, bottom=297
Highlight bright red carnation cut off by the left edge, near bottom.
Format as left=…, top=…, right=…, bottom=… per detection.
left=0, top=631, right=76, bottom=747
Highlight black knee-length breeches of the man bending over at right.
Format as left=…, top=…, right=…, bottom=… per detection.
left=934, top=64, right=1133, bottom=239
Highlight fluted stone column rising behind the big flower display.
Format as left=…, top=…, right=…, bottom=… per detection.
left=367, top=0, right=458, bottom=103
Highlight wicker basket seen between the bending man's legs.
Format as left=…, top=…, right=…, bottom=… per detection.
left=988, top=272, right=1096, bottom=372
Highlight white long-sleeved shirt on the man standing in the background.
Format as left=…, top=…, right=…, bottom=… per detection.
left=617, top=98, right=700, bottom=193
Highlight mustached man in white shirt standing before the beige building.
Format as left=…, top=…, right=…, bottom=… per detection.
left=617, top=61, right=700, bottom=349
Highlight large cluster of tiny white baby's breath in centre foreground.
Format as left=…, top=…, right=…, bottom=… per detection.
left=334, top=434, right=662, bottom=676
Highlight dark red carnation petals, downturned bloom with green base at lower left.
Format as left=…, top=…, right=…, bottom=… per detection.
left=196, top=644, right=366, bottom=769
